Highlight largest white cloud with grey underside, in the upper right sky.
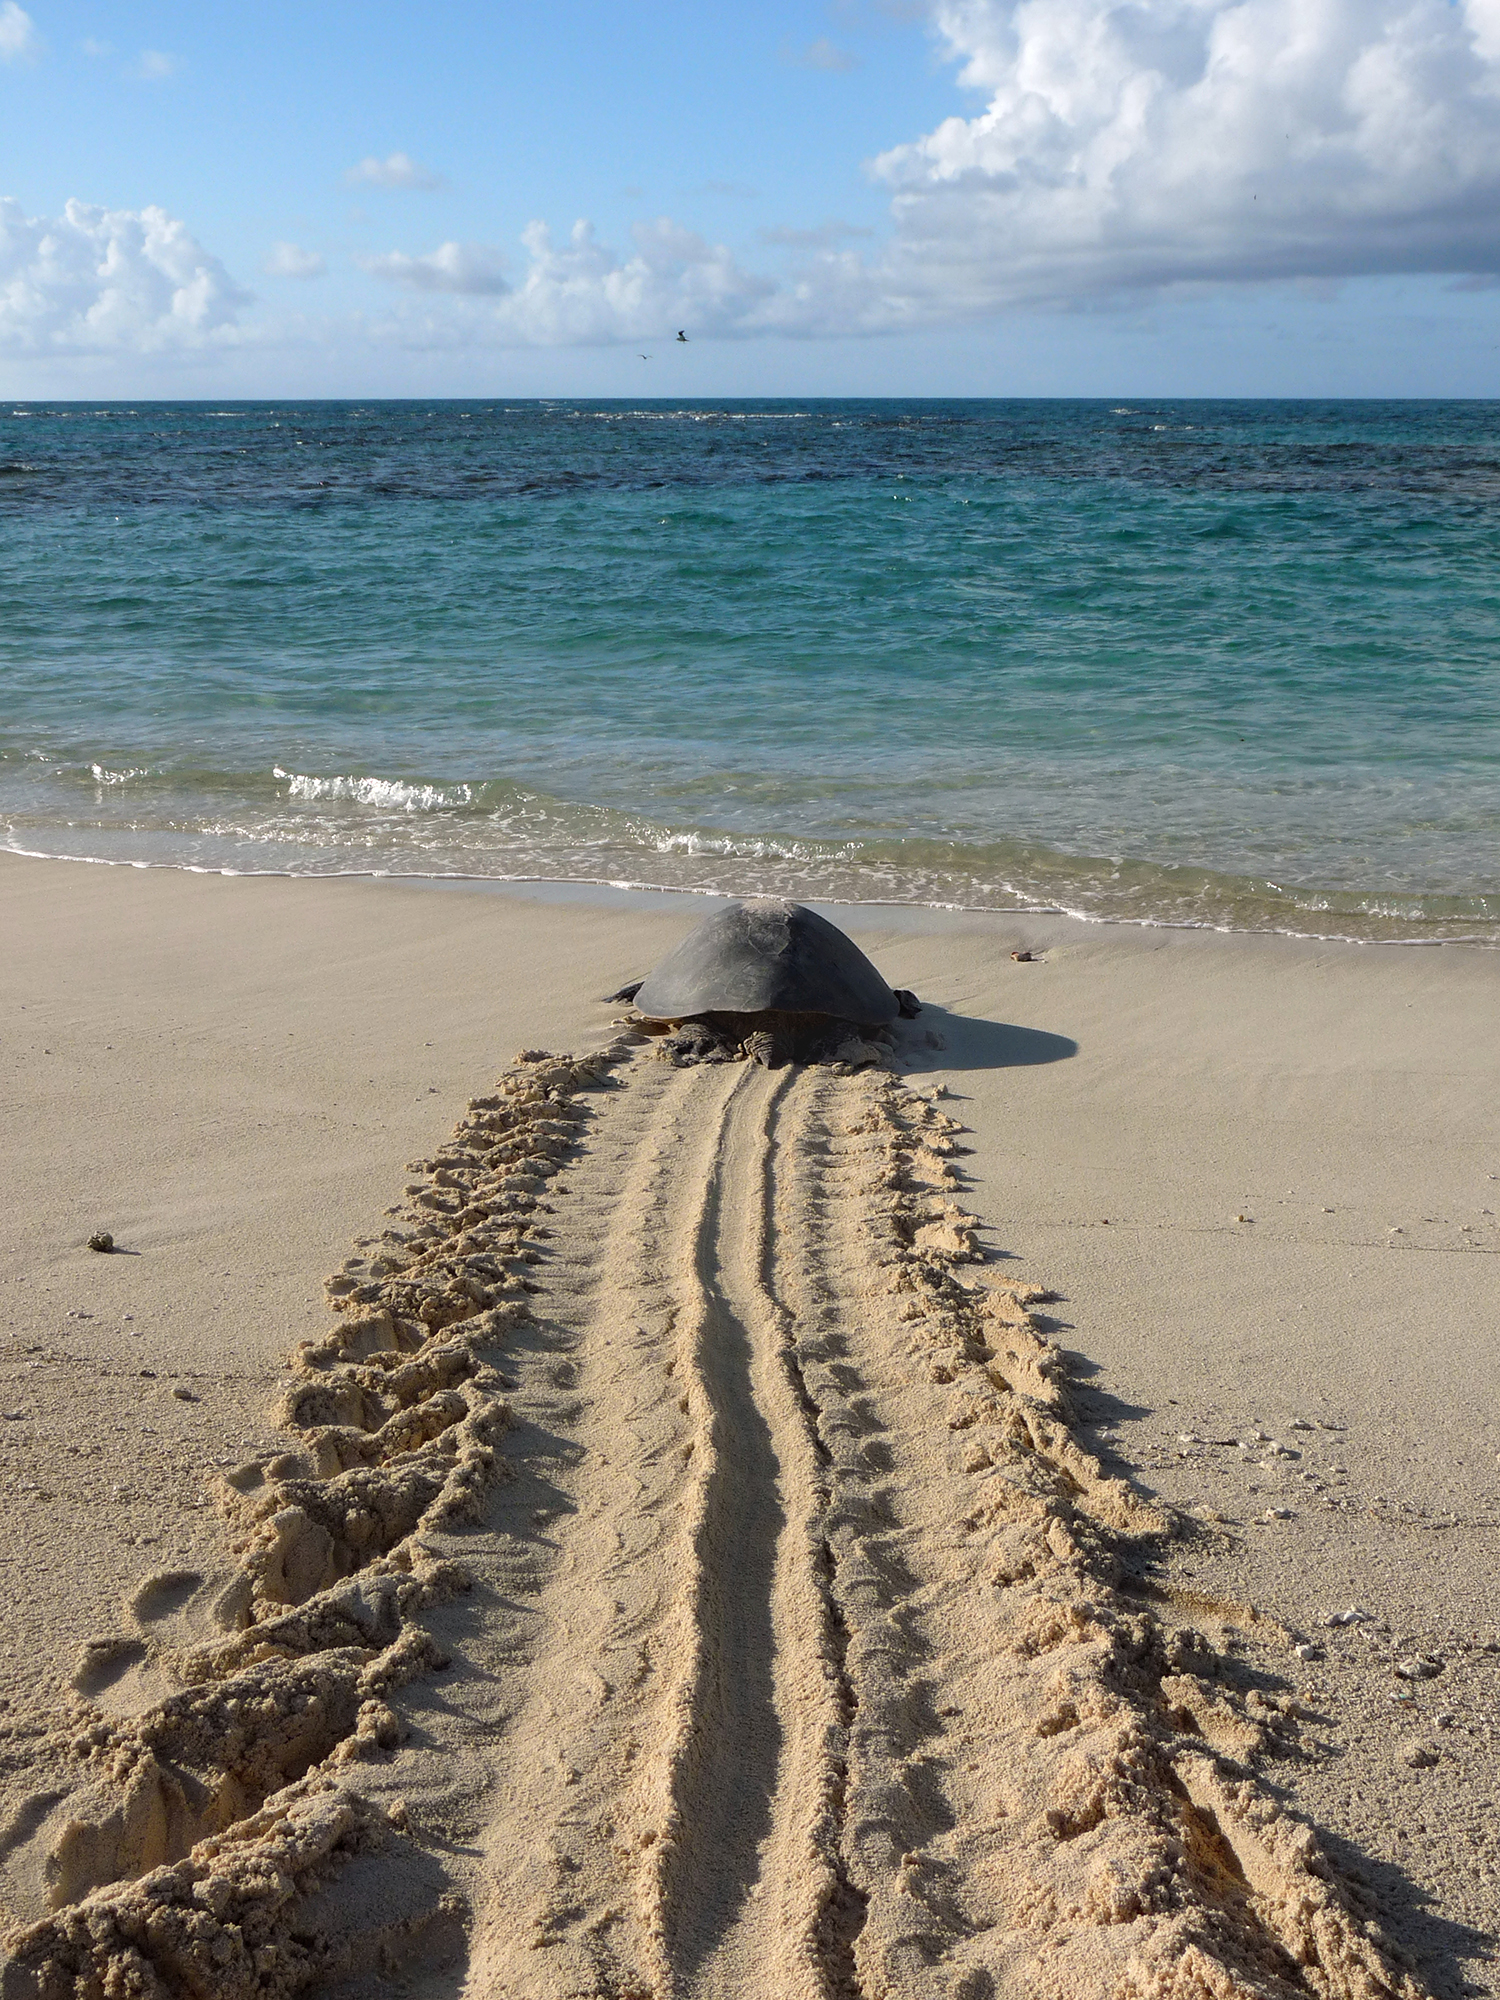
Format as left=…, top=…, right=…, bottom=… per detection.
left=874, top=0, right=1500, bottom=314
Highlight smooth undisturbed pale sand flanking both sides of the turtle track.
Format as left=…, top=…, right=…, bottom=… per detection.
left=0, top=854, right=1500, bottom=2000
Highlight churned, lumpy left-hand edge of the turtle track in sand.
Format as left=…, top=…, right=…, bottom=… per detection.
left=0, top=1044, right=624, bottom=2000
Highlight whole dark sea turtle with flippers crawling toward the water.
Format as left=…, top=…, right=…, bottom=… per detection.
left=610, top=896, right=918, bottom=1070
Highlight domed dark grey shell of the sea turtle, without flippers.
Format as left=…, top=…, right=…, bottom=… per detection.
left=636, top=896, right=900, bottom=1028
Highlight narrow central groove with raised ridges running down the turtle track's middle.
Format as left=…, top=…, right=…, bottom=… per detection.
left=660, top=1070, right=844, bottom=2000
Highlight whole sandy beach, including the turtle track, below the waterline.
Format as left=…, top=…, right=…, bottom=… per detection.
left=0, top=860, right=1500, bottom=2000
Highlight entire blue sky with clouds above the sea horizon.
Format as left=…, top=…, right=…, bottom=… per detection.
left=0, top=0, right=1500, bottom=398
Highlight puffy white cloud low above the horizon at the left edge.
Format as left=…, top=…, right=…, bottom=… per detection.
left=0, top=198, right=248, bottom=354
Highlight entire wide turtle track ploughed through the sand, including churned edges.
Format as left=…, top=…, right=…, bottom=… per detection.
left=6, top=1046, right=1418, bottom=2000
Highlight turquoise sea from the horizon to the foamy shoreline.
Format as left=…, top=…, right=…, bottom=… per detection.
left=0, top=402, right=1500, bottom=942
